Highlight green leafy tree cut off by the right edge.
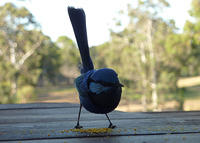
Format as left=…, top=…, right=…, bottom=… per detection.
left=166, top=0, right=200, bottom=110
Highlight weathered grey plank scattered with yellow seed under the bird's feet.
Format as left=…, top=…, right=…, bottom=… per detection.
left=0, top=115, right=200, bottom=141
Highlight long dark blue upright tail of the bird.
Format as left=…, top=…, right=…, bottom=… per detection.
left=68, top=7, right=94, bottom=73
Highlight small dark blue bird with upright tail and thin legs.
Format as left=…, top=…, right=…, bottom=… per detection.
left=68, top=7, right=123, bottom=129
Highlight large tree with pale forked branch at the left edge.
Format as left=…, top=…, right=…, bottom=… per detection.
left=0, top=3, right=61, bottom=103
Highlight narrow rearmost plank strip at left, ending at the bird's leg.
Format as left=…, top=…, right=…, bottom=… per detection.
left=0, top=103, right=79, bottom=110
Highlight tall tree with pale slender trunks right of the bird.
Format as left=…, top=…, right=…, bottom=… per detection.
left=105, top=0, right=175, bottom=110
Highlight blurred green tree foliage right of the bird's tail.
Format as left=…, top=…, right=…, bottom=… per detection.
left=93, top=0, right=200, bottom=109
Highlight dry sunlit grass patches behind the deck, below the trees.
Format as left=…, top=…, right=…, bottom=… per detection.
left=35, top=86, right=200, bottom=111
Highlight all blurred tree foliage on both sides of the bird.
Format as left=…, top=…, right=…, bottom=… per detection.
left=0, top=0, right=200, bottom=110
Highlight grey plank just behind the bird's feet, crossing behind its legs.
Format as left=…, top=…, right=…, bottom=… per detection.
left=0, top=108, right=200, bottom=126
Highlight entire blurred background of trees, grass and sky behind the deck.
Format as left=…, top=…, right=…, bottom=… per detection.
left=0, top=0, right=200, bottom=111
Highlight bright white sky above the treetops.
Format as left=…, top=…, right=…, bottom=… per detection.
left=0, top=0, right=191, bottom=46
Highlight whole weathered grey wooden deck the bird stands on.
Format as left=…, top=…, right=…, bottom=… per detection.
left=0, top=103, right=200, bottom=143
